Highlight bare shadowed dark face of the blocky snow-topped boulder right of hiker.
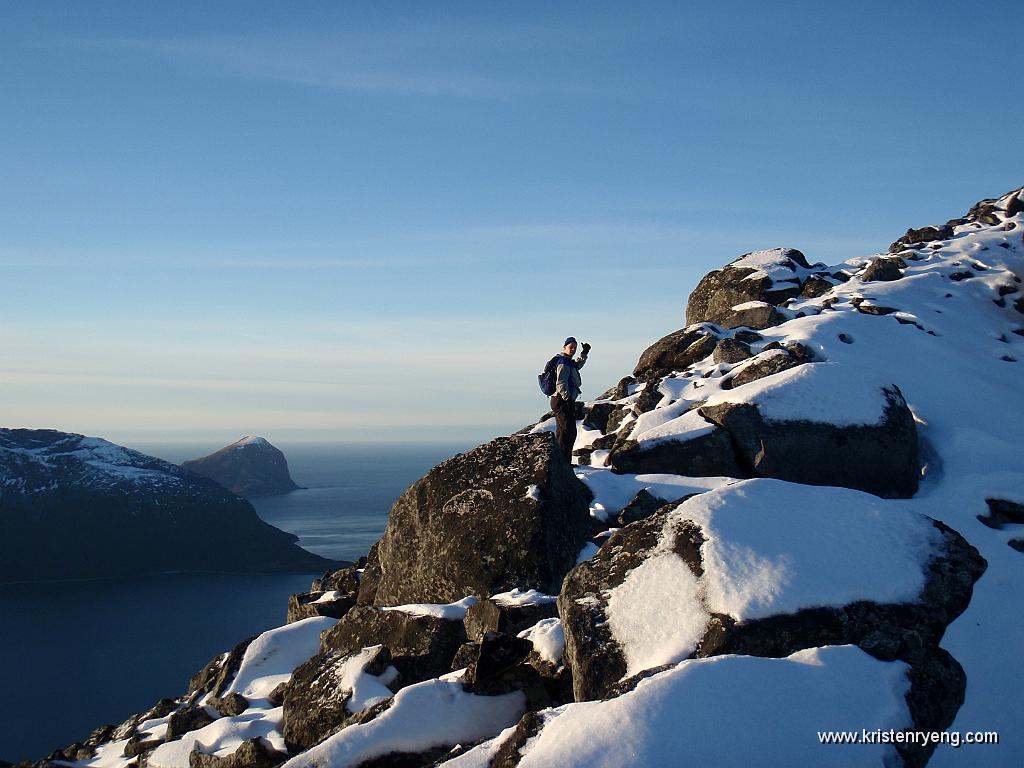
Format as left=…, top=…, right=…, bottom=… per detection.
left=704, top=386, right=920, bottom=498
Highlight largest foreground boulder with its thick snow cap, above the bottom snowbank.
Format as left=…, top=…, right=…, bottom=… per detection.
left=558, top=479, right=985, bottom=700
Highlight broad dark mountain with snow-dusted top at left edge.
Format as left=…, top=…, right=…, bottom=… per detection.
left=0, top=429, right=333, bottom=583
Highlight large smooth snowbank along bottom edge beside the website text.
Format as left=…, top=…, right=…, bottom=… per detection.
left=507, top=645, right=909, bottom=768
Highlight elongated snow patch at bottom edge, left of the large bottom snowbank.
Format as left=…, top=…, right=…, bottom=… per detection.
left=285, top=675, right=526, bottom=768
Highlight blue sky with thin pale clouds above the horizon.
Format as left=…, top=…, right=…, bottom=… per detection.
left=0, top=2, right=1024, bottom=445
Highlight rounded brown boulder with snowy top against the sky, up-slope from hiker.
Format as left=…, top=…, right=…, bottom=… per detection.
left=686, top=248, right=811, bottom=328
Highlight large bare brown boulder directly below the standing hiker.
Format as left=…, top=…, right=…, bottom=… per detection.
left=359, top=434, right=590, bottom=605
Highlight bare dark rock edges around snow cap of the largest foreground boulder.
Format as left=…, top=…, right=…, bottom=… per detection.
left=558, top=507, right=986, bottom=700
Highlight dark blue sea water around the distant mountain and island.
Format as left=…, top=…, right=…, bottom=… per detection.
left=0, top=443, right=469, bottom=762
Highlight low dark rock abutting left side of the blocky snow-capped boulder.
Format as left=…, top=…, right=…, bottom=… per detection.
left=609, top=421, right=749, bottom=477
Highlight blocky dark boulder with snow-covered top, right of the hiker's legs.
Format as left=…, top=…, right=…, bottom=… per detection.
left=699, top=362, right=921, bottom=498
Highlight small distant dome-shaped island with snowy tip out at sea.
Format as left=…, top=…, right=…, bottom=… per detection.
left=181, top=435, right=299, bottom=499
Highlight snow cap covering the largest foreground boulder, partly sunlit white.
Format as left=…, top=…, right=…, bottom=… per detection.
left=607, top=479, right=942, bottom=676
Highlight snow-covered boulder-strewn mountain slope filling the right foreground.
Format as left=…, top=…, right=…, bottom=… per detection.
left=32, top=190, right=1024, bottom=768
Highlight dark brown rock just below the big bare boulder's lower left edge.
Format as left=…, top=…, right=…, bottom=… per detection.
left=321, top=605, right=466, bottom=695
